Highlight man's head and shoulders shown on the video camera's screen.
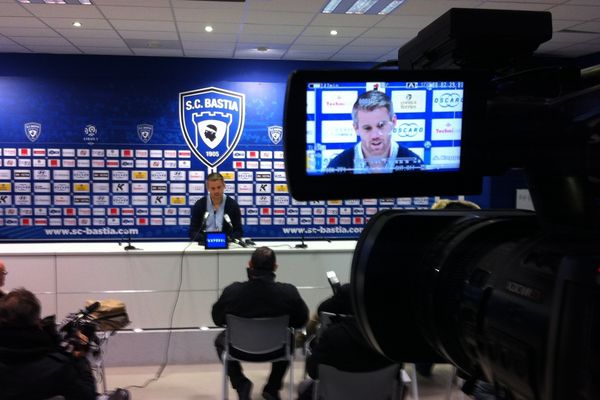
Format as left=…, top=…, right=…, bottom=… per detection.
left=327, top=90, right=423, bottom=174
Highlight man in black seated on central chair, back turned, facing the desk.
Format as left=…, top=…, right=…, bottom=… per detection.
left=212, top=247, right=308, bottom=400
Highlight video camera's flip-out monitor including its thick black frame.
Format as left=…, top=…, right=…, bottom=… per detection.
left=284, top=70, right=485, bottom=200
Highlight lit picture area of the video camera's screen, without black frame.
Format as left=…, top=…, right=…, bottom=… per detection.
left=306, top=81, right=464, bottom=175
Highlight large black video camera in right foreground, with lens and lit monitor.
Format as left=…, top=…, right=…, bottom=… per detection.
left=284, top=9, right=600, bottom=400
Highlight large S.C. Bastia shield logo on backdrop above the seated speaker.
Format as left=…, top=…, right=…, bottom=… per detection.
left=179, top=87, right=246, bottom=168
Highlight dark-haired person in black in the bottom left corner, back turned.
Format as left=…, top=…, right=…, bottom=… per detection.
left=0, top=288, right=96, bottom=400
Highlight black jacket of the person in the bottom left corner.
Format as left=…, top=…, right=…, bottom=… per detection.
left=0, top=328, right=96, bottom=400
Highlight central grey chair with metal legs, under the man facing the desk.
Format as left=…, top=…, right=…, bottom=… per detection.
left=222, top=314, right=294, bottom=400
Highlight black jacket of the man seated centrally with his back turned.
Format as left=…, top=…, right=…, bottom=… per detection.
left=212, top=272, right=308, bottom=328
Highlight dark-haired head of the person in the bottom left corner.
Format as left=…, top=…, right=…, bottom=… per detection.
left=0, top=288, right=42, bottom=328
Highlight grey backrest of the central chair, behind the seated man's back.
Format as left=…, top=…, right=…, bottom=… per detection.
left=225, top=314, right=291, bottom=361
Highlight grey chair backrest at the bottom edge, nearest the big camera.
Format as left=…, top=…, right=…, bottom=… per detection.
left=316, top=364, right=401, bottom=400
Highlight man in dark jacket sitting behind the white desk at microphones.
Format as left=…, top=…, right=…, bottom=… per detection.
left=188, top=172, right=244, bottom=241
